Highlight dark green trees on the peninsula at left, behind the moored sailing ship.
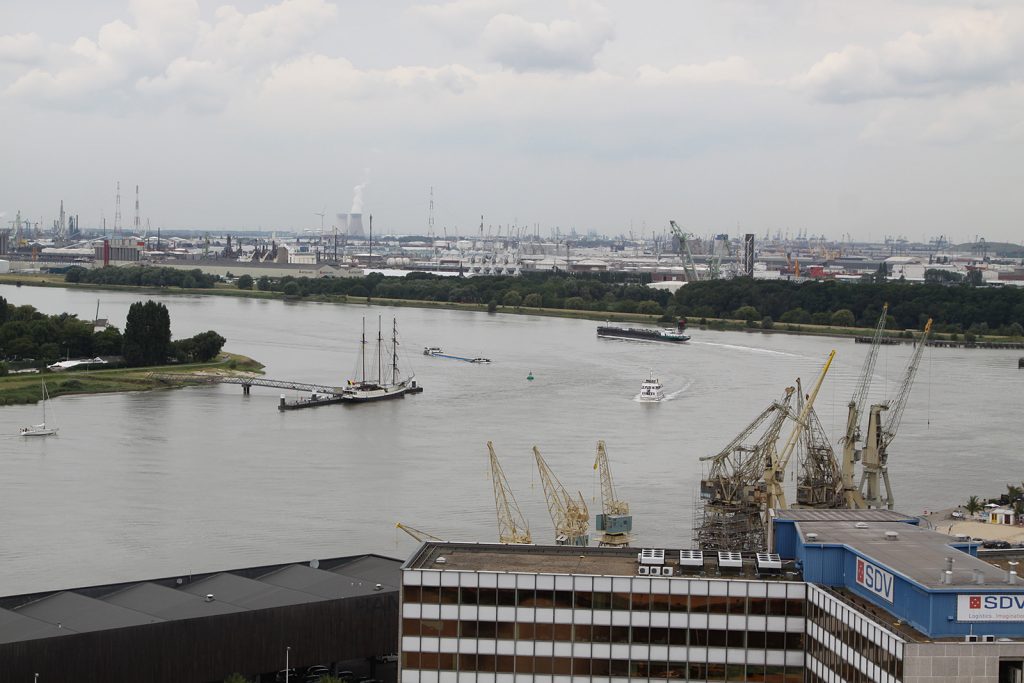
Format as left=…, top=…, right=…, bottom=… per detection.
left=0, top=297, right=225, bottom=373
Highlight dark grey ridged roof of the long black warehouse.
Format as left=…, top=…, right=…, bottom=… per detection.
left=0, top=555, right=401, bottom=643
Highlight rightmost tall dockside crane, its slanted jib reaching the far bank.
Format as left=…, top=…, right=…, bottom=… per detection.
left=860, top=318, right=932, bottom=510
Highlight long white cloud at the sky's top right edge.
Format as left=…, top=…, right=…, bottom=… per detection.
left=795, top=11, right=1024, bottom=101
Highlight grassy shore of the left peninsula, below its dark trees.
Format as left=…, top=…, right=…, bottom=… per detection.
left=0, top=352, right=263, bottom=405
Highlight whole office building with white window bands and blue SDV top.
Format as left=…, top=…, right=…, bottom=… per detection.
left=399, top=510, right=1024, bottom=683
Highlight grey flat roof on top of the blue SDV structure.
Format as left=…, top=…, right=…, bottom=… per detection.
left=797, top=520, right=1007, bottom=591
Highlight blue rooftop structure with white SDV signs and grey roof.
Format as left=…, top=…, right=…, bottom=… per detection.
left=772, top=510, right=1024, bottom=640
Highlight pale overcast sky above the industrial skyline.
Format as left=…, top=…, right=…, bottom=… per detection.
left=0, top=0, right=1024, bottom=243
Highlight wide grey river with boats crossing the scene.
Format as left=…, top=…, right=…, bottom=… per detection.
left=0, top=286, right=1024, bottom=595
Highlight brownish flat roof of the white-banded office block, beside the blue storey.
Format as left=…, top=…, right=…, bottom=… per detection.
left=402, top=542, right=799, bottom=580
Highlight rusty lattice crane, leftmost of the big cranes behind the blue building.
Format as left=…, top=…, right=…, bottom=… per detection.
left=694, top=387, right=794, bottom=552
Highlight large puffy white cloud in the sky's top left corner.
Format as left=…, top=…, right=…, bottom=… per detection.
left=0, top=0, right=337, bottom=110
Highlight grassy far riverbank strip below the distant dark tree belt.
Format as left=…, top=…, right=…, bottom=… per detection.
left=0, top=273, right=1021, bottom=348
